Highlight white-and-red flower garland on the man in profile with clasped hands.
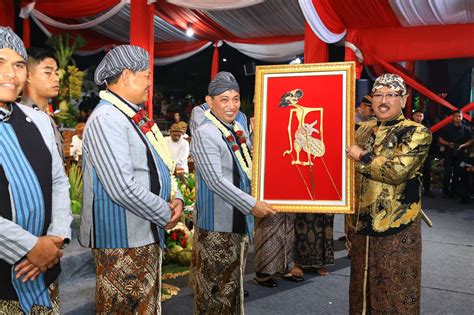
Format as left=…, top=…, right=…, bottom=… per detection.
left=99, top=90, right=178, bottom=200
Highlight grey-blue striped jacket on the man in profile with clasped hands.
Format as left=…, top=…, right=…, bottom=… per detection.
left=80, top=100, right=180, bottom=248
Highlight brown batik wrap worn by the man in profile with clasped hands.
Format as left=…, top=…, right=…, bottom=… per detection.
left=92, top=244, right=161, bottom=314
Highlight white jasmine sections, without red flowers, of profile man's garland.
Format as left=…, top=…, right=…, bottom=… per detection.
left=99, top=90, right=178, bottom=200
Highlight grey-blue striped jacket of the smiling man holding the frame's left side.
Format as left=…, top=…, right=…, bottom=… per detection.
left=191, top=118, right=256, bottom=233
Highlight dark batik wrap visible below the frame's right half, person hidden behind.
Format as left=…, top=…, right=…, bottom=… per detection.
left=295, top=213, right=334, bottom=268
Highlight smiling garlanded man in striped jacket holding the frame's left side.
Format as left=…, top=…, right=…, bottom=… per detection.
left=191, top=72, right=275, bottom=314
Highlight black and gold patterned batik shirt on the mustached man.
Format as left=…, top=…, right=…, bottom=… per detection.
left=353, top=114, right=431, bottom=236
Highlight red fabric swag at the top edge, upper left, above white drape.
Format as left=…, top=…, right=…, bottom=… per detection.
left=20, top=0, right=120, bottom=18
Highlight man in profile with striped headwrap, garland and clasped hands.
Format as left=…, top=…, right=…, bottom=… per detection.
left=81, top=45, right=183, bottom=314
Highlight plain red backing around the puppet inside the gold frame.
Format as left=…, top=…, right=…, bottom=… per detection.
left=262, top=74, right=345, bottom=201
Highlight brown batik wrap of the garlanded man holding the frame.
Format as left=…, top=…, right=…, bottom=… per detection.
left=193, top=227, right=248, bottom=314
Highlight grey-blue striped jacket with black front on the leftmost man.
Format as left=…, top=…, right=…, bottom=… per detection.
left=0, top=104, right=72, bottom=312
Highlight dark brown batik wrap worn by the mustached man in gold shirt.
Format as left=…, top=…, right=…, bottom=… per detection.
left=349, top=217, right=421, bottom=314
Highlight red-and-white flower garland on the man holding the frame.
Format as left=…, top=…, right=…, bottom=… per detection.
left=204, top=109, right=252, bottom=179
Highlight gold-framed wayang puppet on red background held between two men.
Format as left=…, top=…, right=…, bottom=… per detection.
left=252, top=62, right=355, bottom=213
